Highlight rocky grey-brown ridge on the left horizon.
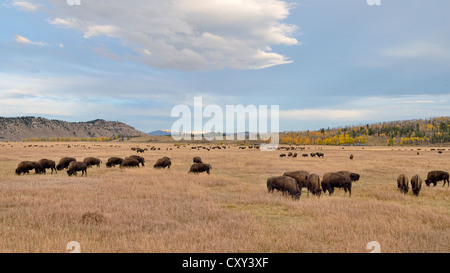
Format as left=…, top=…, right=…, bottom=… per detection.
left=0, top=116, right=147, bottom=141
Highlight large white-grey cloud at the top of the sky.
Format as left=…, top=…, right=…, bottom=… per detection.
left=39, top=0, right=300, bottom=70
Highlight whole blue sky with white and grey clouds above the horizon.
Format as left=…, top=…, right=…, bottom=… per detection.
left=0, top=0, right=450, bottom=132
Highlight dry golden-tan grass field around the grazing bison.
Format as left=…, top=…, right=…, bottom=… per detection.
left=0, top=142, right=450, bottom=253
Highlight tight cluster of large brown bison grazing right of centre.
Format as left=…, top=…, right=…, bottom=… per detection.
left=267, top=170, right=360, bottom=200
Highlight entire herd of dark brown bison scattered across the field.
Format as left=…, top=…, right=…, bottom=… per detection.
left=15, top=144, right=450, bottom=200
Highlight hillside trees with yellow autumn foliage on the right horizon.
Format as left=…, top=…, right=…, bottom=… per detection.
left=280, top=117, right=450, bottom=146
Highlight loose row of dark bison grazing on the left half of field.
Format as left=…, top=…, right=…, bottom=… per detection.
left=15, top=155, right=212, bottom=176
